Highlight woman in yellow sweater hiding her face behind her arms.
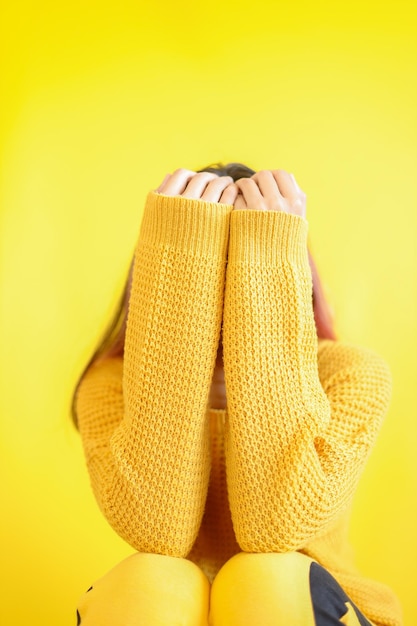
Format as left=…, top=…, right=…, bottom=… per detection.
left=74, top=164, right=401, bottom=626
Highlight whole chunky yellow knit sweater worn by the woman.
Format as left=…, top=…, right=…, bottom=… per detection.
left=76, top=192, right=402, bottom=626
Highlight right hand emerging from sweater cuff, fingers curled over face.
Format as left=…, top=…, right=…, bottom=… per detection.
left=234, top=170, right=307, bottom=218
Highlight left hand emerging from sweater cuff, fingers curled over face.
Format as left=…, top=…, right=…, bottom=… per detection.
left=155, top=169, right=238, bottom=204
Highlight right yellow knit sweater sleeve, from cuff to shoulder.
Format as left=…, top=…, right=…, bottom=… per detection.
left=223, top=210, right=391, bottom=552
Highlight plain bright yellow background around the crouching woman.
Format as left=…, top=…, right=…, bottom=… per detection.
left=0, top=0, right=417, bottom=626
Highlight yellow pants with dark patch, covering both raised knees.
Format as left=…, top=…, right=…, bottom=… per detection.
left=77, top=552, right=371, bottom=626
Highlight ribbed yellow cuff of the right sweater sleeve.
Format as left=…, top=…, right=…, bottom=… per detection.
left=229, top=209, right=308, bottom=265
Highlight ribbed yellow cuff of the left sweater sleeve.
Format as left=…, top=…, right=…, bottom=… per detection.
left=139, top=191, right=233, bottom=256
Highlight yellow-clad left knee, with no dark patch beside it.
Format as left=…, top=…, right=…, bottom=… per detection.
left=78, top=553, right=210, bottom=626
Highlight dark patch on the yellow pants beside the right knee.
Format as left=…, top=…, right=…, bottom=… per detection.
left=310, top=563, right=372, bottom=626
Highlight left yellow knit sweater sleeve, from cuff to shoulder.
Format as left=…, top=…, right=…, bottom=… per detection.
left=77, top=192, right=232, bottom=556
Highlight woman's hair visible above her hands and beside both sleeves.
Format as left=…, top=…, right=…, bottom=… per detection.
left=71, top=163, right=336, bottom=425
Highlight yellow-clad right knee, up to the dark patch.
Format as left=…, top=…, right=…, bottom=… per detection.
left=210, top=552, right=314, bottom=626
